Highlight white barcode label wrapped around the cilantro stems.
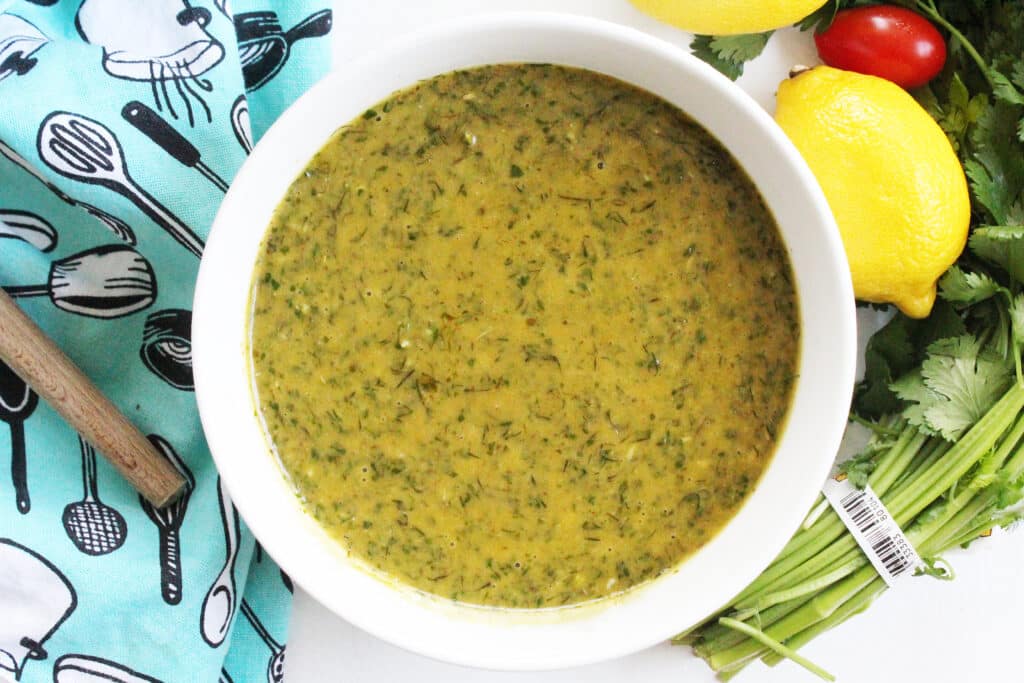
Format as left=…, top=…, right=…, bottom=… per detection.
left=822, top=478, right=923, bottom=586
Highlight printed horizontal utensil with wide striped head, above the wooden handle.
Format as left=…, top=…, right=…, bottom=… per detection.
left=3, top=245, right=157, bottom=317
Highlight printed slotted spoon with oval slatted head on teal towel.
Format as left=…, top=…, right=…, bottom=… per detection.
left=36, top=112, right=204, bottom=256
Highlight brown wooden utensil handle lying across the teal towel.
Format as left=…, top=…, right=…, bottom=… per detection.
left=0, top=291, right=185, bottom=508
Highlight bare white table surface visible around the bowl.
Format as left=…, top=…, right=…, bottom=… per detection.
left=285, top=0, right=1024, bottom=683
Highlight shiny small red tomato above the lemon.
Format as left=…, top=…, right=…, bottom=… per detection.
left=814, top=5, right=946, bottom=88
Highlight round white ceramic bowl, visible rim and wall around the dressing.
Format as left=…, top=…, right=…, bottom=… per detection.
left=193, top=13, right=855, bottom=670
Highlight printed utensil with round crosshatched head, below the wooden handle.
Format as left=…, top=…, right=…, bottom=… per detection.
left=61, top=436, right=128, bottom=555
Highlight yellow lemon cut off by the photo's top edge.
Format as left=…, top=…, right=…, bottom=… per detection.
left=630, top=0, right=825, bottom=36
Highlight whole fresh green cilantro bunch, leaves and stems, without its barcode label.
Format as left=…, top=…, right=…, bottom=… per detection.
left=674, top=0, right=1024, bottom=680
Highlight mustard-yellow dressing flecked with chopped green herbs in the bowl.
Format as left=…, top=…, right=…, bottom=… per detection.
left=252, top=65, right=800, bottom=607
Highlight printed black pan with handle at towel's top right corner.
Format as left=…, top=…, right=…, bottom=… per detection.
left=234, top=9, right=333, bottom=91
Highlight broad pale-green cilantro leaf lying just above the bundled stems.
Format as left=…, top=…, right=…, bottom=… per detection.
left=892, top=335, right=1013, bottom=441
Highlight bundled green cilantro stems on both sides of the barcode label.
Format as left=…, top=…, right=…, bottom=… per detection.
left=673, top=383, right=1024, bottom=680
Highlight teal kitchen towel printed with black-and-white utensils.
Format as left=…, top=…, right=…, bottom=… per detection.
left=0, top=0, right=332, bottom=683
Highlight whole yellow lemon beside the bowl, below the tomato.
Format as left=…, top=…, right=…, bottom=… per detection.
left=775, top=67, right=971, bottom=317
